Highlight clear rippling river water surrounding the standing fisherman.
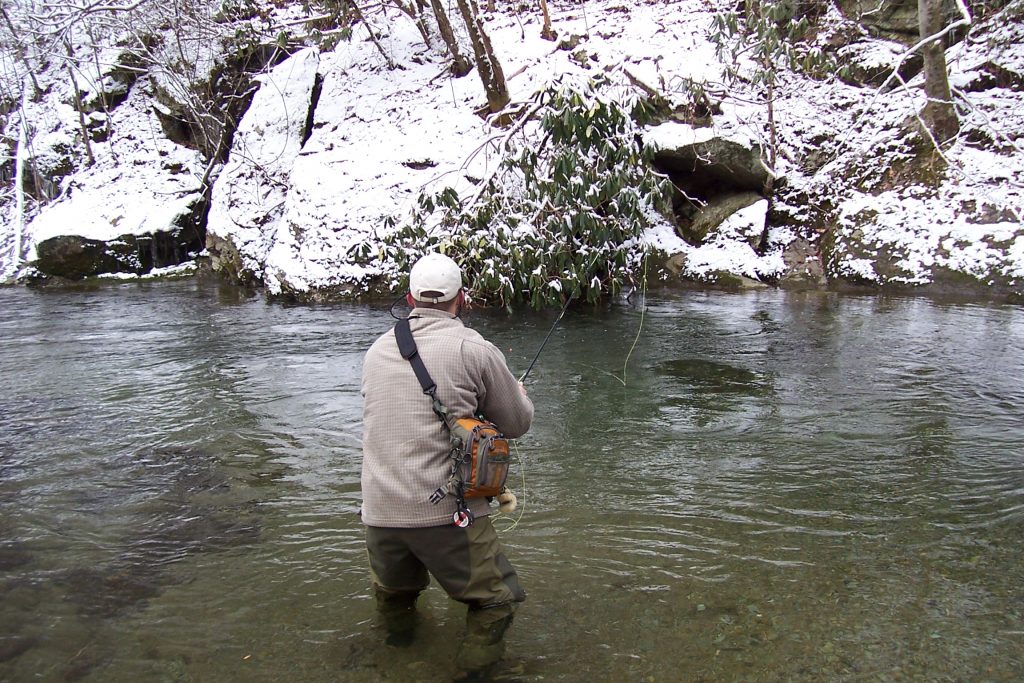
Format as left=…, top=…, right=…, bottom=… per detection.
left=0, top=280, right=1024, bottom=683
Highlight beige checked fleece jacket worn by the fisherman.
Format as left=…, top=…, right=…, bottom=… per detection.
left=361, top=308, right=534, bottom=527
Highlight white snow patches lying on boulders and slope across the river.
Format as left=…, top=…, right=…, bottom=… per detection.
left=0, top=0, right=1024, bottom=292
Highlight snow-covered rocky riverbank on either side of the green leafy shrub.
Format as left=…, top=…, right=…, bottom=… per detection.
left=0, top=0, right=1024, bottom=301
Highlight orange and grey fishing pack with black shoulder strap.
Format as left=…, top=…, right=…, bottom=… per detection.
left=394, top=318, right=511, bottom=527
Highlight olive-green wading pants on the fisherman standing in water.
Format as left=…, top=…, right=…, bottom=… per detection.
left=367, top=516, right=526, bottom=670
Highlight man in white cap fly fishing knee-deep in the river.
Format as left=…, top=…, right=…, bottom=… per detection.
left=360, top=253, right=534, bottom=680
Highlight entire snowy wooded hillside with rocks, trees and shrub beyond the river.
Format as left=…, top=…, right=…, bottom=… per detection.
left=0, top=0, right=1024, bottom=307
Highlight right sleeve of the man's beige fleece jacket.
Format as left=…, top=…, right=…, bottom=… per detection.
left=464, top=340, right=534, bottom=438
